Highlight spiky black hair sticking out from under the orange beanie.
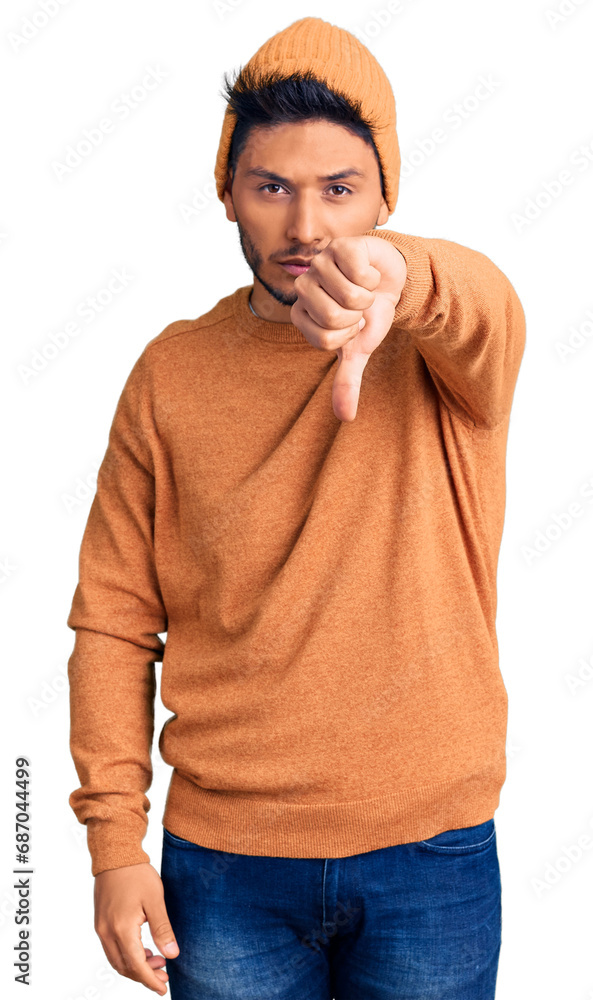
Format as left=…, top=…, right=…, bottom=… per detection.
left=221, top=66, right=385, bottom=197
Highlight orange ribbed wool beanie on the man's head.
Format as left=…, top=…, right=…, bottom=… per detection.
left=214, top=17, right=401, bottom=213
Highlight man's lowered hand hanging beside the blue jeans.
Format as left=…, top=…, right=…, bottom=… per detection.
left=95, top=862, right=179, bottom=996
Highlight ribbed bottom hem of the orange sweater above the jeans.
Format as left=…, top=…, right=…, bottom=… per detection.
left=162, top=762, right=505, bottom=858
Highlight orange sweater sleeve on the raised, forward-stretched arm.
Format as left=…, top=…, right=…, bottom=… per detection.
left=364, top=229, right=525, bottom=428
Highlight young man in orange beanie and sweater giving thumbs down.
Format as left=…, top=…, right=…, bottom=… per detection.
left=68, top=17, right=525, bottom=1000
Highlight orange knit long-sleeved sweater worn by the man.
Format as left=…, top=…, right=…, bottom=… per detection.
left=68, top=229, right=525, bottom=875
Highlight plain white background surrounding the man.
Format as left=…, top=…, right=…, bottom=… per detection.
left=0, top=0, right=593, bottom=1000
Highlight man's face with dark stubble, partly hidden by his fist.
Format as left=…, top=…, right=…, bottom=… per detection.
left=224, top=121, right=389, bottom=322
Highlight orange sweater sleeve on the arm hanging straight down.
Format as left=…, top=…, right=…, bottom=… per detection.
left=67, top=352, right=167, bottom=875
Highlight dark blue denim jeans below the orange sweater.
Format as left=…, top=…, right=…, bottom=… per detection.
left=161, top=819, right=502, bottom=1000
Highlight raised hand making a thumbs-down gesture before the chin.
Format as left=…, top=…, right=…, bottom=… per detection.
left=290, top=236, right=408, bottom=421
